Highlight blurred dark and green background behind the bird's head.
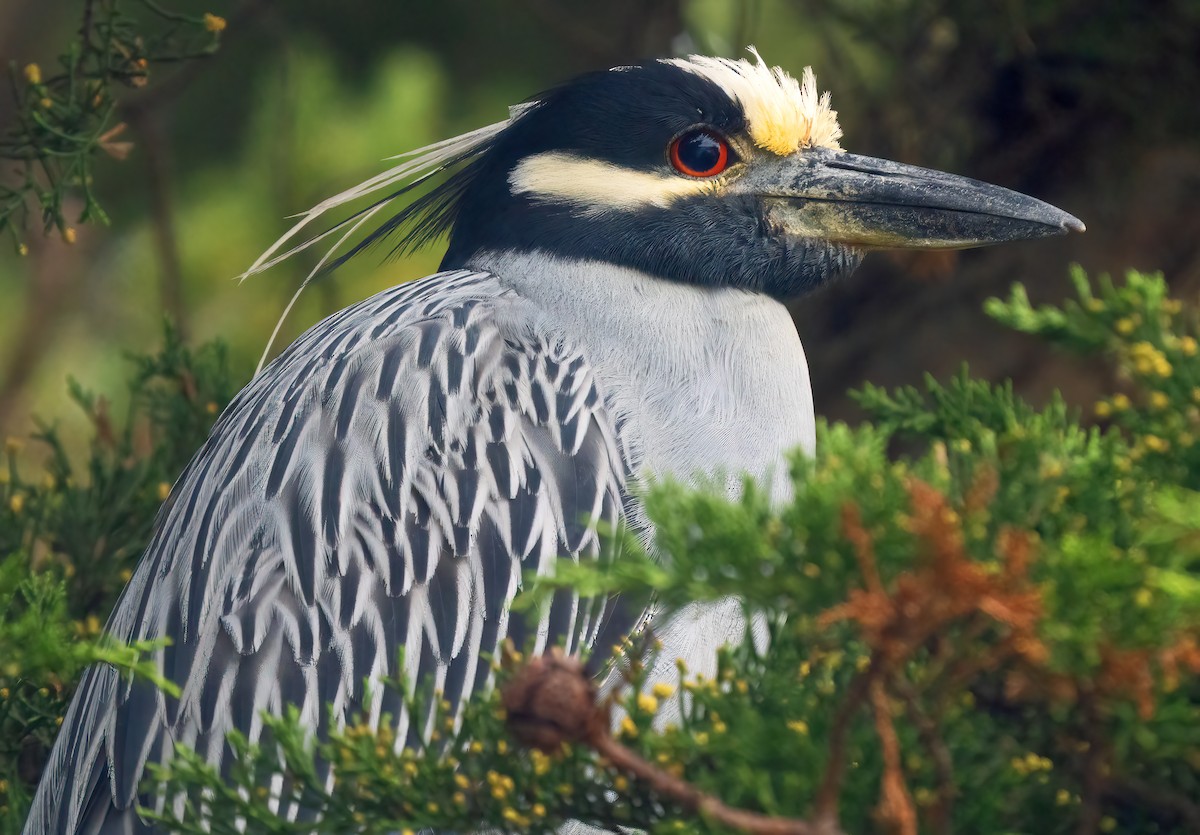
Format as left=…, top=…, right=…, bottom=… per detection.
left=0, top=0, right=1200, bottom=435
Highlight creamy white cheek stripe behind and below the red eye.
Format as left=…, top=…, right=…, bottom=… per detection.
left=509, top=151, right=720, bottom=214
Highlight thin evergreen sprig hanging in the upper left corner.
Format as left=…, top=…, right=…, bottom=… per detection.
left=0, top=0, right=226, bottom=252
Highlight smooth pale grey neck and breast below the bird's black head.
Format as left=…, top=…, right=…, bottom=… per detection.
left=470, top=252, right=815, bottom=501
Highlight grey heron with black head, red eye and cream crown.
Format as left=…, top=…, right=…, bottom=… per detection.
left=24, top=50, right=1084, bottom=835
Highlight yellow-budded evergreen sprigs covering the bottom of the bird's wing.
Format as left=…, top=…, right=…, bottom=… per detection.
left=135, top=656, right=678, bottom=835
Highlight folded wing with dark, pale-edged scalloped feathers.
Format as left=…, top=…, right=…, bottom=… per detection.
left=25, top=271, right=631, bottom=834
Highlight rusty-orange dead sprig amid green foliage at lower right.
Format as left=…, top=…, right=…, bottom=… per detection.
left=815, top=482, right=1046, bottom=835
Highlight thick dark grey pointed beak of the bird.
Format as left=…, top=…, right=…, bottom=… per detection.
left=734, top=148, right=1084, bottom=250
